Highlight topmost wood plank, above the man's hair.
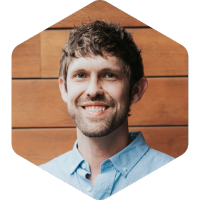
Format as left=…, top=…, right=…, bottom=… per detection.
left=49, top=0, right=148, bottom=28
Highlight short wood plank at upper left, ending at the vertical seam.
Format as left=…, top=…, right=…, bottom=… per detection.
left=11, top=33, right=40, bottom=78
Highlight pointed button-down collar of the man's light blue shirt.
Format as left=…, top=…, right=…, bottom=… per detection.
left=66, top=131, right=149, bottom=177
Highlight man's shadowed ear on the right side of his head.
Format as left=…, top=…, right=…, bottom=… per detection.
left=131, top=76, right=148, bottom=104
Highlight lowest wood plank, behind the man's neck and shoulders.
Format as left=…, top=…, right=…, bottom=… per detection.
left=12, top=127, right=188, bottom=166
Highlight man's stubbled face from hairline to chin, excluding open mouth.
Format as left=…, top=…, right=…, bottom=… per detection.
left=63, top=56, right=130, bottom=137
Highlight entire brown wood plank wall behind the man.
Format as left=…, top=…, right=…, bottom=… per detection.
left=11, top=0, right=188, bottom=166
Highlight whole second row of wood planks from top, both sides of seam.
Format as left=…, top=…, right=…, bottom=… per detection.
left=12, top=29, right=188, bottom=78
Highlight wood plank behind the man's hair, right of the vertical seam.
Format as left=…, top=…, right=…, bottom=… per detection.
left=41, top=29, right=188, bottom=78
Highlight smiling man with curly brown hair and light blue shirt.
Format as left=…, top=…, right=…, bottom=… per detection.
left=39, top=21, right=174, bottom=199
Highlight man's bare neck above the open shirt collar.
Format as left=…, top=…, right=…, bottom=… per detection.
left=77, top=120, right=133, bottom=175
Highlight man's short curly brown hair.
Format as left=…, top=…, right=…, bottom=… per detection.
left=58, top=20, right=144, bottom=116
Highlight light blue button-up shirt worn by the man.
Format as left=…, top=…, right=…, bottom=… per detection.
left=39, top=131, right=175, bottom=200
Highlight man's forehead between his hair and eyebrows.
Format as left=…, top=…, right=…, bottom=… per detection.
left=68, top=56, right=122, bottom=73
